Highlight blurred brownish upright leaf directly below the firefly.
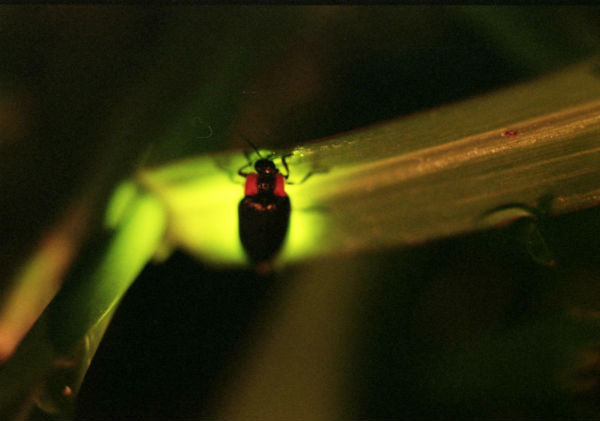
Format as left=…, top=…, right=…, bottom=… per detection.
left=207, top=259, right=373, bottom=420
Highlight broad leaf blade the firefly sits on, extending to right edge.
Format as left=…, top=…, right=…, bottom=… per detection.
left=137, top=59, right=600, bottom=264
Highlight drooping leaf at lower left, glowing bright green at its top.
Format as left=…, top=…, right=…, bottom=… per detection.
left=0, top=189, right=165, bottom=419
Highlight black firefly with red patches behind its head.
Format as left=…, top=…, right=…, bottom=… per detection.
left=238, top=148, right=291, bottom=265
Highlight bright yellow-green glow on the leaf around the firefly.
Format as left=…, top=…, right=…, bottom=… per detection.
left=140, top=151, right=327, bottom=265
